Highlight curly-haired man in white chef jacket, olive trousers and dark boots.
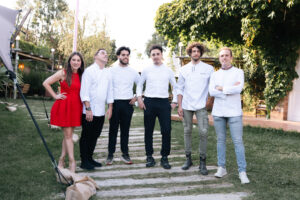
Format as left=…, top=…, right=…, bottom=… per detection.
left=177, top=42, right=214, bottom=175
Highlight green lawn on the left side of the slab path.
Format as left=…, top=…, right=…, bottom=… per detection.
left=0, top=100, right=71, bottom=199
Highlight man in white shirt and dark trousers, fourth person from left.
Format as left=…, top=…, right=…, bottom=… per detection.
left=137, top=45, right=177, bottom=169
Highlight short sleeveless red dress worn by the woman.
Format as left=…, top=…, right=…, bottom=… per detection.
left=50, top=73, right=82, bottom=127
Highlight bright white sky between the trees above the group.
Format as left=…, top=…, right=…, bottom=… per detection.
left=0, top=0, right=171, bottom=53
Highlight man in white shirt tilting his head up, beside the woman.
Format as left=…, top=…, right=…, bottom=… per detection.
left=79, top=49, right=114, bottom=170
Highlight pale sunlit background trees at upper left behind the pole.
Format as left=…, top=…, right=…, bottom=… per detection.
left=17, top=0, right=116, bottom=69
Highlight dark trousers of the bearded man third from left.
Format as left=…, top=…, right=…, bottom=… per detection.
left=108, top=100, right=133, bottom=156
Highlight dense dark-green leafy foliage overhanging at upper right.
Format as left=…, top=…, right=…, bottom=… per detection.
left=155, top=0, right=300, bottom=115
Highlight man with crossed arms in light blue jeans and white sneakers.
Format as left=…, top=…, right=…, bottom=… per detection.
left=209, top=47, right=250, bottom=184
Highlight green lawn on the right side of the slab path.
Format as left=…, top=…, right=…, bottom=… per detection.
left=172, top=119, right=300, bottom=200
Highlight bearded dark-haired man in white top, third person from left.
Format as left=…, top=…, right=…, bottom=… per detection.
left=106, top=46, right=140, bottom=165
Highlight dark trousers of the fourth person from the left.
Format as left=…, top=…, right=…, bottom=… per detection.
left=144, top=97, right=171, bottom=156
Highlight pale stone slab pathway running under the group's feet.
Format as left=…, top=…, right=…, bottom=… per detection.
left=77, top=126, right=248, bottom=200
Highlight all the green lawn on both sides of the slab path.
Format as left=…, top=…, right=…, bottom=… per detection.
left=0, top=99, right=300, bottom=200
